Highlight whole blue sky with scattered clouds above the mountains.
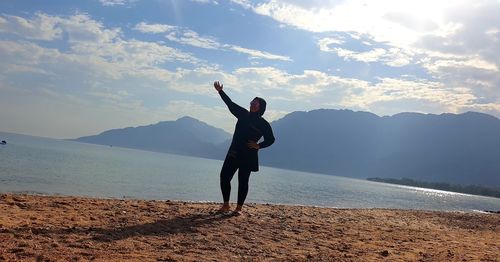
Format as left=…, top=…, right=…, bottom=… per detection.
left=0, top=0, right=500, bottom=138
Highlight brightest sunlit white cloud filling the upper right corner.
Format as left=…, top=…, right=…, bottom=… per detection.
left=233, top=0, right=500, bottom=65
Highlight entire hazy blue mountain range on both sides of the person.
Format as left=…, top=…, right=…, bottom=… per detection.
left=75, top=109, right=500, bottom=187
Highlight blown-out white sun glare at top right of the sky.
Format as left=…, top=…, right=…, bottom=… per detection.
left=322, top=0, right=465, bottom=46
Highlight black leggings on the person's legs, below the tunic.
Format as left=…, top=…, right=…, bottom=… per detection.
left=220, top=157, right=251, bottom=205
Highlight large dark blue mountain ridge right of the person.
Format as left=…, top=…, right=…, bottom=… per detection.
left=261, top=110, right=500, bottom=186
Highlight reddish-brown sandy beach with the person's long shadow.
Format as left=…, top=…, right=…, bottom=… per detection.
left=0, top=194, right=500, bottom=261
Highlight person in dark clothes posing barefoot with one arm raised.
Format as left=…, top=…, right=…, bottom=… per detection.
left=214, top=81, right=275, bottom=215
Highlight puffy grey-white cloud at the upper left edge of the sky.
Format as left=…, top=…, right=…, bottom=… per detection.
left=0, top=14, right=201, bottom=79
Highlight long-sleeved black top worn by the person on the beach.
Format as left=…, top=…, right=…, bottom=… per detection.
left=219, top=90, right=275, bottom=171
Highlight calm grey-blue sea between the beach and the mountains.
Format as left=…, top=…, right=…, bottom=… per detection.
left=0, top=132, right=500, bottom=211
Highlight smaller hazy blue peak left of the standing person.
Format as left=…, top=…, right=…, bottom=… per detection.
left=74, top=117, right=230, bottom=159
